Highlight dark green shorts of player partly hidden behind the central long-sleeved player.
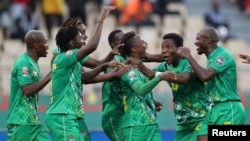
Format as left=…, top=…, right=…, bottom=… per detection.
left=102, top=115, right=122, bottom=141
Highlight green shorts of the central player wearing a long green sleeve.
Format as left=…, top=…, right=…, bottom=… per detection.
left=122, top=124, right=162, bottom=141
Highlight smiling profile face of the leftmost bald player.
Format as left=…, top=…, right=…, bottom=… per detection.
left=35, top=35, right=49, bottom=57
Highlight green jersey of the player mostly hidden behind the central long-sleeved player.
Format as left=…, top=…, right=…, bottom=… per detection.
left=102, top=55, right=124, bottom=116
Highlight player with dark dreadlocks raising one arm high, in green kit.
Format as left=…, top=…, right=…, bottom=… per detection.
left=46, top=6, right=119, bottom=140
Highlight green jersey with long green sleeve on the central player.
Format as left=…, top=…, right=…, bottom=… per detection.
left=121, top=69, right=160, bottom=127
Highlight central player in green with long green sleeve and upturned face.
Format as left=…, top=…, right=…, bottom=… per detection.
left=120, top=32, right=174, bottom=141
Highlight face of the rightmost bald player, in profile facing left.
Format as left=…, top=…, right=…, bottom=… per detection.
left=194, top=31, right=207, bottom=55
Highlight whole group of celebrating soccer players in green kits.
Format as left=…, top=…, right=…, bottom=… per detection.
left=7, top=6, right=246, bottom=141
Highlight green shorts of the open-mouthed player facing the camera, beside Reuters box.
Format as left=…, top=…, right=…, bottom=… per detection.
left=175, top=117, right=208, bottom=141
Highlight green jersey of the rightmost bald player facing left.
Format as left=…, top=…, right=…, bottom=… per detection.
left=207, top=46, right=240, bottom=102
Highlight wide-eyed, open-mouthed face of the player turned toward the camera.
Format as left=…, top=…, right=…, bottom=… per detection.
left=161, top=39, right=180, bottom=64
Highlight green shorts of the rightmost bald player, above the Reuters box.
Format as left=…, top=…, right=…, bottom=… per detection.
left=208, top=101, right=246, bottom=125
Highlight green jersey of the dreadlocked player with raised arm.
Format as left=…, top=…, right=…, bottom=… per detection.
left=47, top=49, right=83, bottom=117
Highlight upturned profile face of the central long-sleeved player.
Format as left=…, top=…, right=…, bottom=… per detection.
left=133, top=35, right=148, bottom=58
